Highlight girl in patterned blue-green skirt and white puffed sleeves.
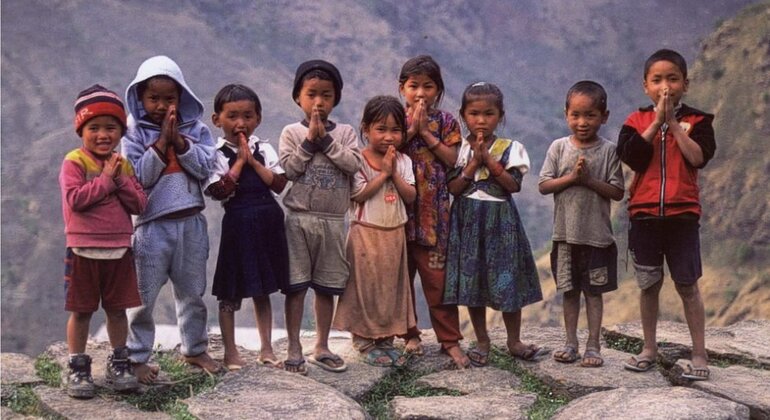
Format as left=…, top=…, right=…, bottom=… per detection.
left=444, top=82, right=544, bottom=367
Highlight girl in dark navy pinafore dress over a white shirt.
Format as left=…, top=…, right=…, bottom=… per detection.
left=205, top=85, right=289, bottom=370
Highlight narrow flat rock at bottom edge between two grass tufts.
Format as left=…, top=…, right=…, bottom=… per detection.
left=388, top=392, right=536, bottom=420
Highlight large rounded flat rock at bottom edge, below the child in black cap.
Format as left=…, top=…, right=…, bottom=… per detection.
left=184, top=366, right=366, bottom=420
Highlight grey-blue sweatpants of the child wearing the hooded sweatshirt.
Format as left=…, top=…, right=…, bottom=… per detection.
left=127, top=213, right=209, bottom=363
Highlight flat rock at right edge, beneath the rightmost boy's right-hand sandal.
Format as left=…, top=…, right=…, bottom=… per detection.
left=669, top=359, right=770, bottom=420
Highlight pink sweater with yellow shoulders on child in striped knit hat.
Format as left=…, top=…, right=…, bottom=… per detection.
left=59, top=148, right=147, bottom=248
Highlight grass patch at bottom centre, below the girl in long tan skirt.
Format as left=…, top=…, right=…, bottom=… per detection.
left=361, top=369, right=462, bottom=419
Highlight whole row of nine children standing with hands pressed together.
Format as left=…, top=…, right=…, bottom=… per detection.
left=60, top=50, right=715, bottom=398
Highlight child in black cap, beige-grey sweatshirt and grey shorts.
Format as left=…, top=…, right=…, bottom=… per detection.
left=278, top=60, right=362, bottom=374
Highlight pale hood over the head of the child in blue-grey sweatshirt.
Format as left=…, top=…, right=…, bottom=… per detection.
left=126, top=55, right=203, bottom=124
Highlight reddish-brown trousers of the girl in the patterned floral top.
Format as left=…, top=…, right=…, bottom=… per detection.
left=401, top=243, right=463, bottom=350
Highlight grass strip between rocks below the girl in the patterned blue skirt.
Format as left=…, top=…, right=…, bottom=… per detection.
left=489, top=347, right=568, bottom=420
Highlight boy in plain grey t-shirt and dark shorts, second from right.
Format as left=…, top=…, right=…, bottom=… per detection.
left=539, top=80, right=623, bottom=367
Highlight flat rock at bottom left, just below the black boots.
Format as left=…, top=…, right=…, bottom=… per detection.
left=35, top=385, right=171, bottom=420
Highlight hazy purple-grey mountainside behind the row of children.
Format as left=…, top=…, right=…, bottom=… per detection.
left=1, top=0, right=768, bottom=353
